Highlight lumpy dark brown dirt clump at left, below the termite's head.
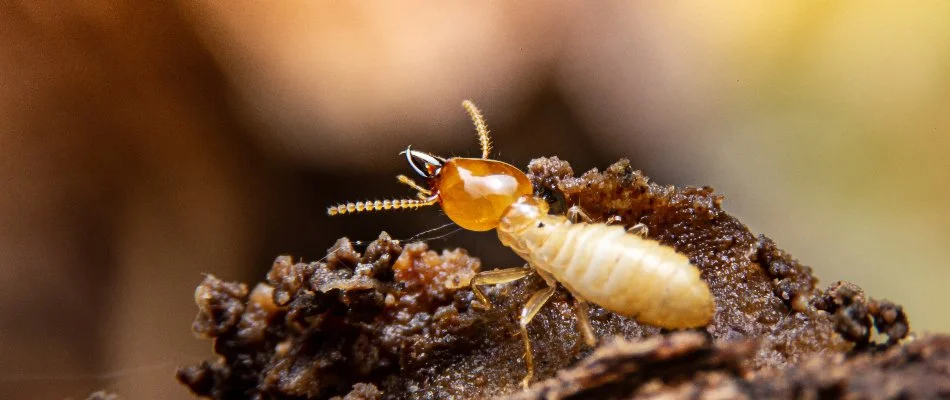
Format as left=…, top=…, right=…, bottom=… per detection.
left=178, top=233, right=494, bottom=398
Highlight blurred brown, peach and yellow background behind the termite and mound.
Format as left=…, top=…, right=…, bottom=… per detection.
left=0, top=0, right=950, bottom=399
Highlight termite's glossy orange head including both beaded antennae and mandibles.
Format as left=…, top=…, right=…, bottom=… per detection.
left=327, top=100, right=533, bottom=231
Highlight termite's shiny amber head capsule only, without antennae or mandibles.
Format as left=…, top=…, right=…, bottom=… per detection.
left=437, top=158, right=532, bottom=231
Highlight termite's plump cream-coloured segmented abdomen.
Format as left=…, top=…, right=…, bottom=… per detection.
left=521, top=223, right=715, bottom=328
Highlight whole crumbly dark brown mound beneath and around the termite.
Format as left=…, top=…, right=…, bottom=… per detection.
left=178, top=158, right=936, bottom=399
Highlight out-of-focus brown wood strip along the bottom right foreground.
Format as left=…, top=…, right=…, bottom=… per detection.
left=509, top=332, right=950, bottom=400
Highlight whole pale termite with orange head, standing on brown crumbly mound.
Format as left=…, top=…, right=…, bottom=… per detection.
left=327, top=100, right=715, bottom=386
